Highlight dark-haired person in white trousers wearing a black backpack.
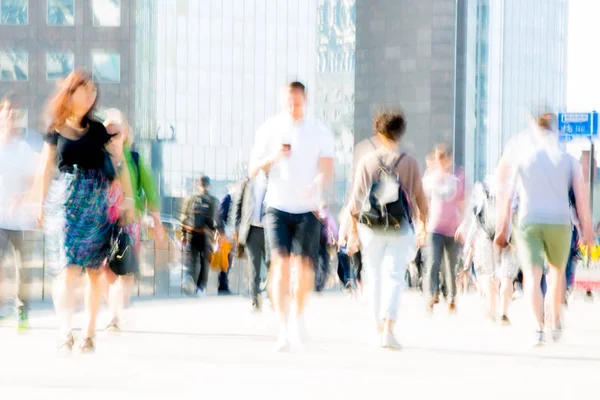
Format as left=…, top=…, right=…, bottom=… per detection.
left=347, top=111, right=427, bottom=349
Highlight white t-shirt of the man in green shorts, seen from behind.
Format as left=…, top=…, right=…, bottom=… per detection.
left=504, top=130, right=581, bottom=225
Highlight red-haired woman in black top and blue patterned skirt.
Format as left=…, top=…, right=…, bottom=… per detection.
left=39, top=70, right=131, bottom=352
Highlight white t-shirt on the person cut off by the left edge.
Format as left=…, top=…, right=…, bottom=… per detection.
left=0, top=139, right=38, bottom=230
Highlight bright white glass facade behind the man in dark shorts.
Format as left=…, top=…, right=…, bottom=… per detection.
left=148, top=0, right=355, bottom=215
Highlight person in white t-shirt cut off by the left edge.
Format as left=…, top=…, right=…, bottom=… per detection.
left=0, top=92, right=36, bottom=330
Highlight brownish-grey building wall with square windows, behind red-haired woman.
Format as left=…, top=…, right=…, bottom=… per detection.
left=0, top=0, right=136, bottom=134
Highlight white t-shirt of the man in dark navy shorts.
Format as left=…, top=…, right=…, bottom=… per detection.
left=251, top=114, right=335, bottom=214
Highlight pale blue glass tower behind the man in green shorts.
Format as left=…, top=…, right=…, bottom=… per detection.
left=487, top=0, right=568, bottom=172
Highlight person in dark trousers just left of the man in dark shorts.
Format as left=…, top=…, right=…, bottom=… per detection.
left=233, top=174, right=269, bottom=311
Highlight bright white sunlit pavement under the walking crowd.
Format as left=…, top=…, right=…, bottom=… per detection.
left=0, top=292, right=600, bottom=400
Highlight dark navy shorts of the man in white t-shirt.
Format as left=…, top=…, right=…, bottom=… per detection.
left=264, top=208, right=321, bottom=260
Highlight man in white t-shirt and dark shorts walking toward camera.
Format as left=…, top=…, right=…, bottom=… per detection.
left=250, top=82, right=334, bottom=351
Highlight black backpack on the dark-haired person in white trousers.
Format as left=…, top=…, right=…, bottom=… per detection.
left=358, top=153, right=412, bottom=230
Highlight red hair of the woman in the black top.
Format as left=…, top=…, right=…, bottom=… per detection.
left=47, top=68, right=95, bottom=130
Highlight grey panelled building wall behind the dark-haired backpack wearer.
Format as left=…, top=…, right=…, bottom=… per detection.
left=355, top=0, right=463, bottom=165
